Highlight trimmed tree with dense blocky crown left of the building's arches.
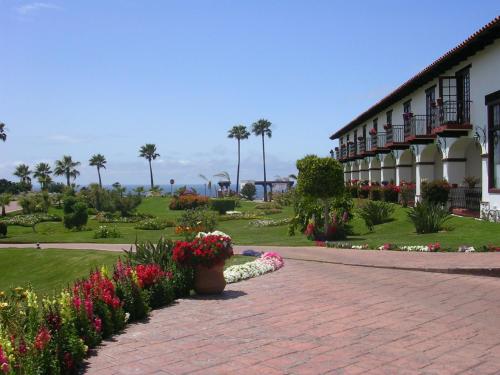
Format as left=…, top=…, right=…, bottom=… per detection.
left=297, top=155, right=344, bottom=233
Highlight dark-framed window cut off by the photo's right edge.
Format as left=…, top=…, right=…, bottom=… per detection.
left=486, top=91, right=500, bottom=192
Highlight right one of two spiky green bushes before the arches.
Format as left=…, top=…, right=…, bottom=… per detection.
left=408, top=201, right=451, bottom=234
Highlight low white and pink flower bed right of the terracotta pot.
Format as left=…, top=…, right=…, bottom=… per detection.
left=224, top=252, right=285, bottom=284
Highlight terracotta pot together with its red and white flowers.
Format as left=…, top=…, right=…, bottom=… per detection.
left=172, top=231, right=233, bottom=294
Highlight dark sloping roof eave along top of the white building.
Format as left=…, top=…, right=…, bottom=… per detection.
left=330, top=16, right=500, bottom=140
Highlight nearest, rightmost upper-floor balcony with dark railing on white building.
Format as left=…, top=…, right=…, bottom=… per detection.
left=431, top=99, right=472, bottom=137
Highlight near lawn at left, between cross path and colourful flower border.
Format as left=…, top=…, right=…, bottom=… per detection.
left=0, top=249, right=255, bottom=294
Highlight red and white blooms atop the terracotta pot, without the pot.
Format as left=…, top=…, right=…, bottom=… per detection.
left=172, top=232, right=233, bottom=268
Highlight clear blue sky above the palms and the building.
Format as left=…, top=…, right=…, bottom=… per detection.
left=0, top=0, right=500, bottom=185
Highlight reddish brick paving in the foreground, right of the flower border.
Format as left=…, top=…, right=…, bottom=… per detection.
left=87, top=260, right=500, bottom=374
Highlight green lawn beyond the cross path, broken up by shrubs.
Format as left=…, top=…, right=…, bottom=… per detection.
left=0, top=197, right=500, bottom=250
